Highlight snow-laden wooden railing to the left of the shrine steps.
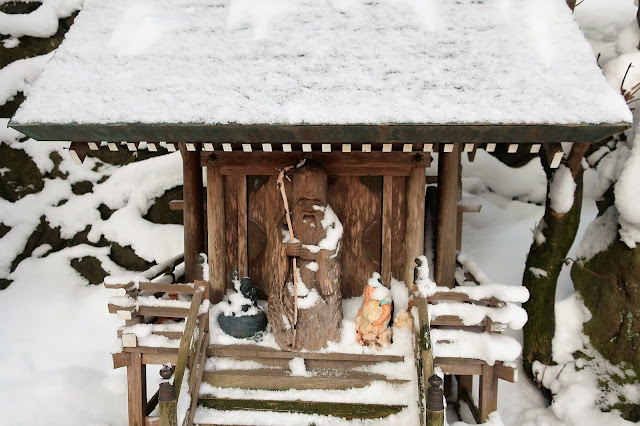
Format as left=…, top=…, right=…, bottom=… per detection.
left=104, top=255, right=210, bottom=425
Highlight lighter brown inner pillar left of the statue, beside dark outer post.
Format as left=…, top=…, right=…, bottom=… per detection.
left=207, top=166, right=227, bottom=303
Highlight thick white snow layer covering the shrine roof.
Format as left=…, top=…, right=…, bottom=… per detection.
left=13, top=0, right=631, bottom=124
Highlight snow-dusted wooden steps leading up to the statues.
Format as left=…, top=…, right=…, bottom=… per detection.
left=195, top=345, right=409, bottom=425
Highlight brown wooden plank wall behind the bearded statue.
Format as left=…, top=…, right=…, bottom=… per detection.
left=236, top=175, right=406, bottom=297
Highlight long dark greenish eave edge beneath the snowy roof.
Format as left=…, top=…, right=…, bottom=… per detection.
left=9, top=122, right=631, bottom=144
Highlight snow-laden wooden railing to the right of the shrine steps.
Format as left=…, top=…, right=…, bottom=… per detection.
left=415, top=254, right=529, bottom=422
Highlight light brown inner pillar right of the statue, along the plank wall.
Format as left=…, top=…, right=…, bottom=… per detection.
left=402, top=167, right=427, bottom=288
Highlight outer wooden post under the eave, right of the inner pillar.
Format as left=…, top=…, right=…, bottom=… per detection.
left=435, top=143, right=460, bottom=287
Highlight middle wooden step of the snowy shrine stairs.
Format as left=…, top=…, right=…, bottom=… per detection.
left=202, top=368, right=408, bottom=390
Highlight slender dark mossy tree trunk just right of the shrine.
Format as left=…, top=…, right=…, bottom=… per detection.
left=522, top=143, right=589, bottom=382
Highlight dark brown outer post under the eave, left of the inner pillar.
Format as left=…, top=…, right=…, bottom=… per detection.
left=180, top=143, right=204, bottom=283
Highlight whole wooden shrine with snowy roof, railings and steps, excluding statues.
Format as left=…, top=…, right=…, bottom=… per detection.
left=9, top=0, right=631, bottom=426
